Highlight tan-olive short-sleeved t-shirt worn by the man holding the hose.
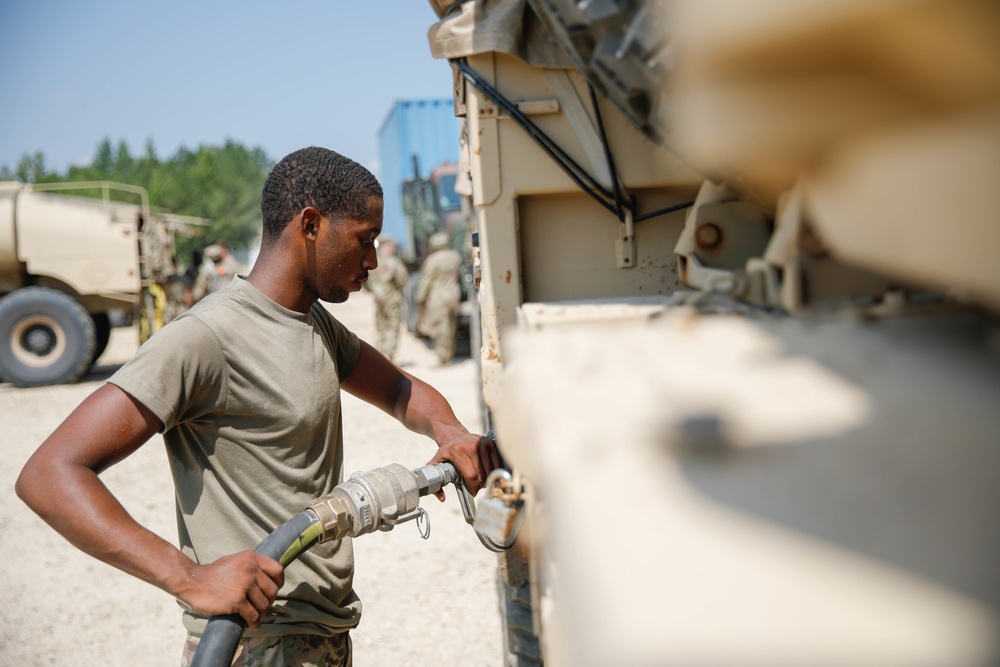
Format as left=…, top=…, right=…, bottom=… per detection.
left=110, top=277, right=361, bottom=636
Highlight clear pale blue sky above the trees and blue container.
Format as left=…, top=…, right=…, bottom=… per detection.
left=0, top=0, right=451, bottom=180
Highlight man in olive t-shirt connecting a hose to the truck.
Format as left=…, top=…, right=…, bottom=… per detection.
left=16, top=147, right=500, bottom=667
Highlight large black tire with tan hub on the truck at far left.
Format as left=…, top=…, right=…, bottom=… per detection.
left=0, top=287, right=96, bottom=387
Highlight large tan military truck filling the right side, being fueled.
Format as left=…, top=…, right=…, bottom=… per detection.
left=429, top=0, right=1000, bottom=667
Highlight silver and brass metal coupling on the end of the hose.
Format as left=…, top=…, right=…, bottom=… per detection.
left=309, top=462, right=458, bottom=542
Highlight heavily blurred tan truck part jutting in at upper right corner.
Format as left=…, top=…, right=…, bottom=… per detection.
left=665, top=0, right=1000, bottom=310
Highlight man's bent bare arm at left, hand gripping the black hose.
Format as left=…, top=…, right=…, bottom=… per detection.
left=16, top=384, right=284, bottom=628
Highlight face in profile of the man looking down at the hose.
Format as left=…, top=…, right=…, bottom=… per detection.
left=312, top=197, right=382, bottom=303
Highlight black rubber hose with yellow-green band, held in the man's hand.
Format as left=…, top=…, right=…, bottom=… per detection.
left=191, top=510, right=323, bottom=667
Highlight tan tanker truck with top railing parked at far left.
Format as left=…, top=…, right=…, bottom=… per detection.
left=0, top=181, right=188, bottom=387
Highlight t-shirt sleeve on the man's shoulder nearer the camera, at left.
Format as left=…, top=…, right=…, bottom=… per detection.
left=108, top=317, right=227, bottom=431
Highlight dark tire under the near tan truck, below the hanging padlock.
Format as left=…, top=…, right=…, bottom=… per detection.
left=497, top=545, right=542, bottom=667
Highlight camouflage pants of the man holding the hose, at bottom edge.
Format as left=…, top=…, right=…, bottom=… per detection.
left=181, top=632, right=353, bottom=667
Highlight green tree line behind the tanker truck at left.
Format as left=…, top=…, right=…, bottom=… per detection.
left=0, top=138, right=274, bottom=262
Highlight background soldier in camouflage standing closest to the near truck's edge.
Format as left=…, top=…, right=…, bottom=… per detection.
left=417, top=232, right=462, bottom=366
